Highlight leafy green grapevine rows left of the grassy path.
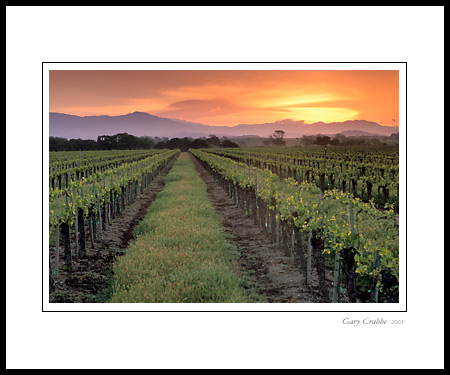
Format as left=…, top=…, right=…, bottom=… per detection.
left=49, top=150, right=179, bottom=296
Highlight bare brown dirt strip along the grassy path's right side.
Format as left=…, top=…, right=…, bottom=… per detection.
left=191, top=155, right=333, bottom=303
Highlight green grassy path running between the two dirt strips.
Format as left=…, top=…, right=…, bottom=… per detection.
left=110, top=153, right=256, bottom=303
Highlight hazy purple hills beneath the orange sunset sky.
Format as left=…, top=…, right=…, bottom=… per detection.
left=49, top=112, right=399, bottom=140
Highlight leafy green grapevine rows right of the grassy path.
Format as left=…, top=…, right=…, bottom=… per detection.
left=191, top=148, right=399, bottom=302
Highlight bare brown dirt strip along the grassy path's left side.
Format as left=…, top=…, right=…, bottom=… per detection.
left=49, top=161, right=174, bottom=303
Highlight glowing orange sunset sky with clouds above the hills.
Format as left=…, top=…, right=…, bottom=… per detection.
left=49, top=70, right=399, bottom=126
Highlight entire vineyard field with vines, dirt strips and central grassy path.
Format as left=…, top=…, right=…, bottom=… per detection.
left=49, top=146, right=399, bottom=303
